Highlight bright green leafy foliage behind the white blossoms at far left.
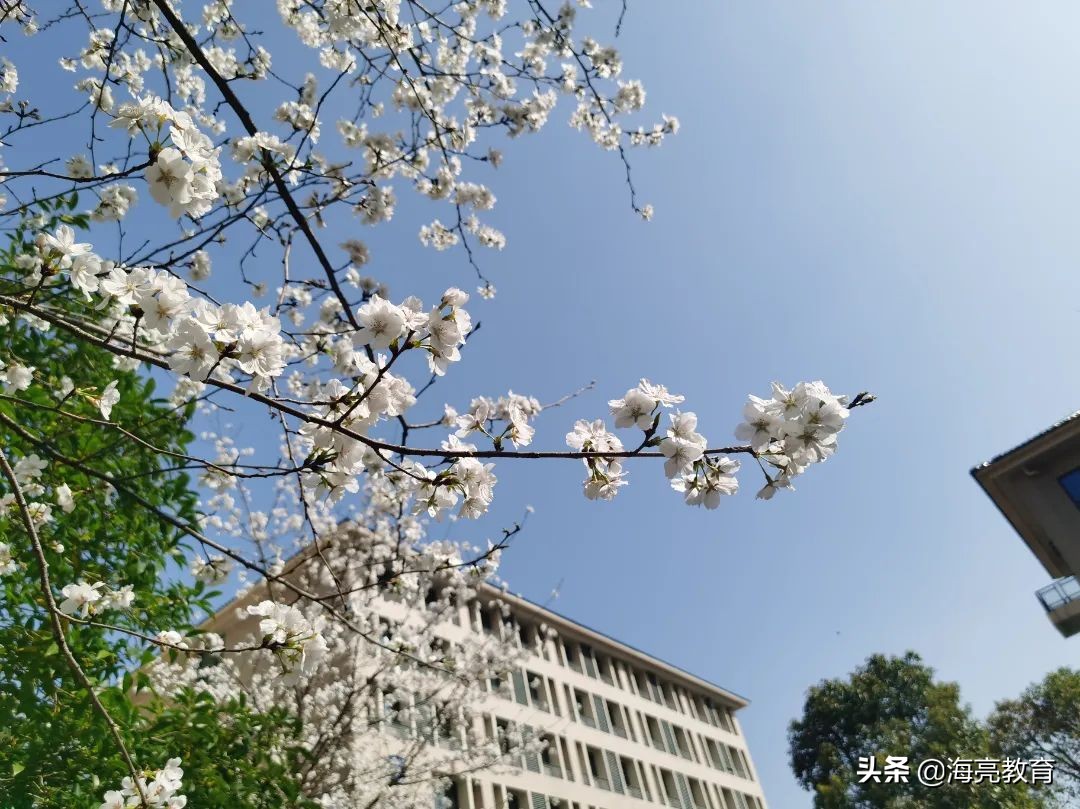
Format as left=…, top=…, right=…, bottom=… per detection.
left=0, top=209, right=308, bottom=809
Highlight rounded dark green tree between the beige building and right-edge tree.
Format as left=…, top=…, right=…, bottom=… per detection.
left=788, top=651, right=1039, bottom=809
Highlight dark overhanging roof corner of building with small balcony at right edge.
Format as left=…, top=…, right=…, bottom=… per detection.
left=971, top=413, right=1080, bottom=637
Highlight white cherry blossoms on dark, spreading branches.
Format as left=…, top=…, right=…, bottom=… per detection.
left=0, top=0, right=873, bottom=809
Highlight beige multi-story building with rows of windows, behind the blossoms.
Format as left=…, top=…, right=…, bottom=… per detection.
left=208, top=585, right=766, bottom=809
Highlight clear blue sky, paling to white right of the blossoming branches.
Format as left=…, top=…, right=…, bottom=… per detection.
left=12, top=0, right=1080, bottom=809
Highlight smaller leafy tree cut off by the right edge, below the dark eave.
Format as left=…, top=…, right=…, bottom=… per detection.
left=988, top=668, right=1080, bottom=801
